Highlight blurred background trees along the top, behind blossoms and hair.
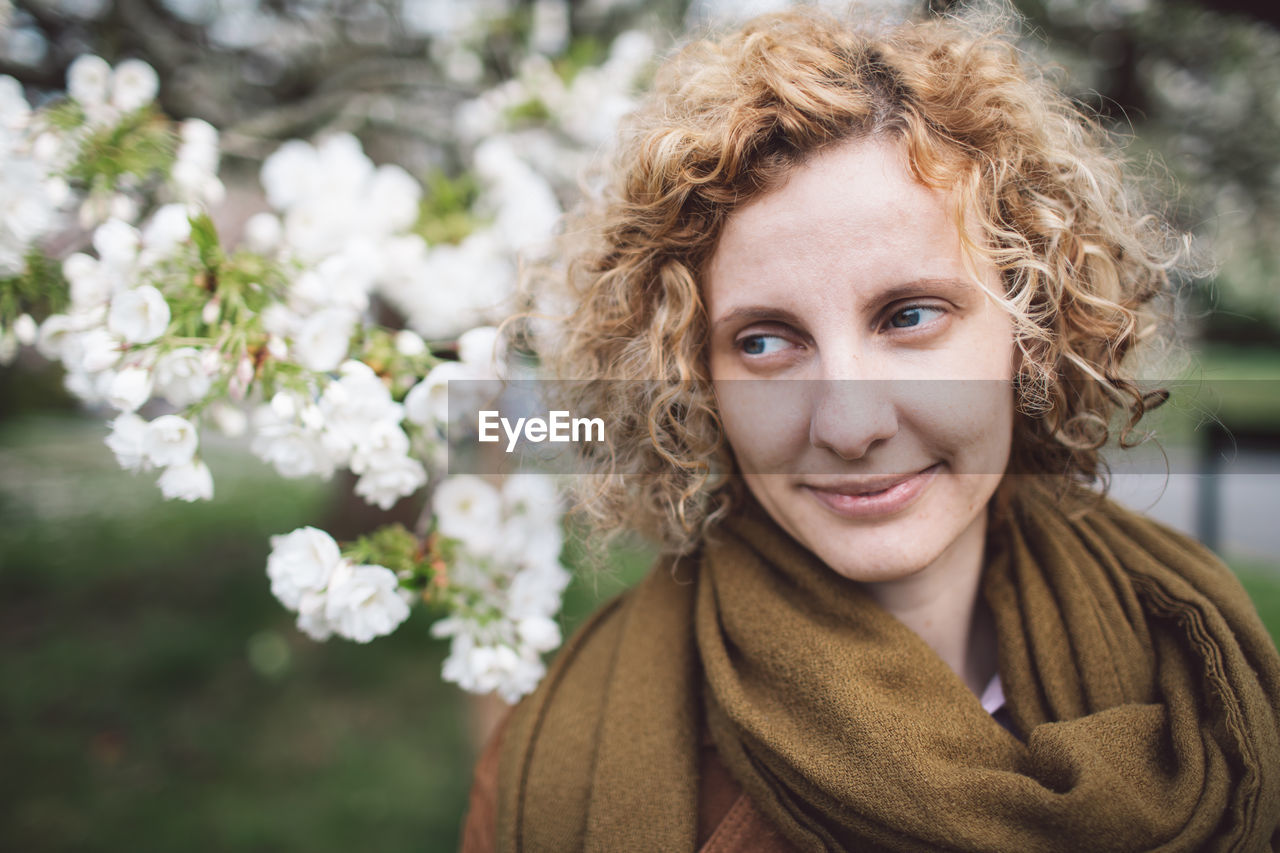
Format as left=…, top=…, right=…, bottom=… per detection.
left=0, top=0, right=1280, bottom=333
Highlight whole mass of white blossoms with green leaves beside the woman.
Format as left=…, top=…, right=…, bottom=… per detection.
left=0, top=27, right=653, bottom=701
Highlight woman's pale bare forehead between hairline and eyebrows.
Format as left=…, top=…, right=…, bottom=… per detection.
left=707, top=138, right=966, bottom=313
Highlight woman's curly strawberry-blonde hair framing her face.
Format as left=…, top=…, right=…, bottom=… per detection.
left=524, top=4, right=1178, bottom=551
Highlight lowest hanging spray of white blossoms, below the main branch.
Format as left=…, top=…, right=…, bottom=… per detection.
left=268, top=474, right=570, bottom=702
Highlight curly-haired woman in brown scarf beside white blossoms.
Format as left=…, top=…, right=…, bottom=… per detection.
left=463, top=13, right=1280, bottom=850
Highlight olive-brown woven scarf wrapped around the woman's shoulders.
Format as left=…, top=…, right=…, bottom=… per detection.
left=498, top=488, right=1280, bottom=853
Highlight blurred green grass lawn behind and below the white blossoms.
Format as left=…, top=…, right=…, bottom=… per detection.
left=0, top=409, right=1280, bottom=853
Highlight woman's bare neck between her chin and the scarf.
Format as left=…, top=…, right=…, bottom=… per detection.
left=864, top=512, right=997, bottom=697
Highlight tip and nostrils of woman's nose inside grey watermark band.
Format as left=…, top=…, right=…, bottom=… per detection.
left=809, top=379, right=899, bottom=461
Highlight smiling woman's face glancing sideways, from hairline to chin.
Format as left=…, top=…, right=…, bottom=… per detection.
left=705, top=140, right=1014, bottom=581
